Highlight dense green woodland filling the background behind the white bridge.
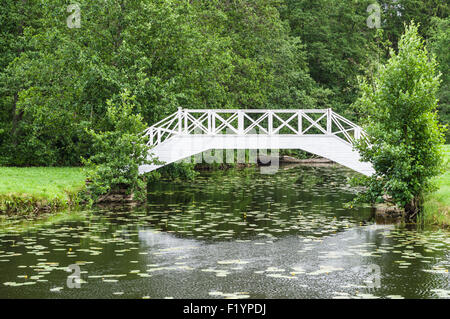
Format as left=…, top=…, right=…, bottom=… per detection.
left=0, top=0, right=449, bottom=166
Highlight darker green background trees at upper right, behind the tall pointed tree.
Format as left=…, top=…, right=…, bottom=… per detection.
left=279, top=0, right=450, bottom=119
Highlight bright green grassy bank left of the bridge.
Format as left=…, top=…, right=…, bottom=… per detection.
left=0, top=167, right=85, bottom=214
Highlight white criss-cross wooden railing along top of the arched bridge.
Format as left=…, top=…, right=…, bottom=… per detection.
left=144, top=108, right=367, bottom=146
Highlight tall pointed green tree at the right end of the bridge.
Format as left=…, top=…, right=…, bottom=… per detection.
left=356, top=23, right=444, bottom=220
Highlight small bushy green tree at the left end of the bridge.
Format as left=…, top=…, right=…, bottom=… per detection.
left=83, top=91, right=152, bottom=201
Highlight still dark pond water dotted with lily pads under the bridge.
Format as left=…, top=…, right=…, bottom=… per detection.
left=0, top=166, right=450, bottom=298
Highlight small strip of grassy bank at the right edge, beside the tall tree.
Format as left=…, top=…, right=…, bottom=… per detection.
left=422, top=145, right=450, bottom=226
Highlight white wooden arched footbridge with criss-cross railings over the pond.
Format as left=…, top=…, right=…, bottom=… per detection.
left=139, top=108, right=374, bottom=176
